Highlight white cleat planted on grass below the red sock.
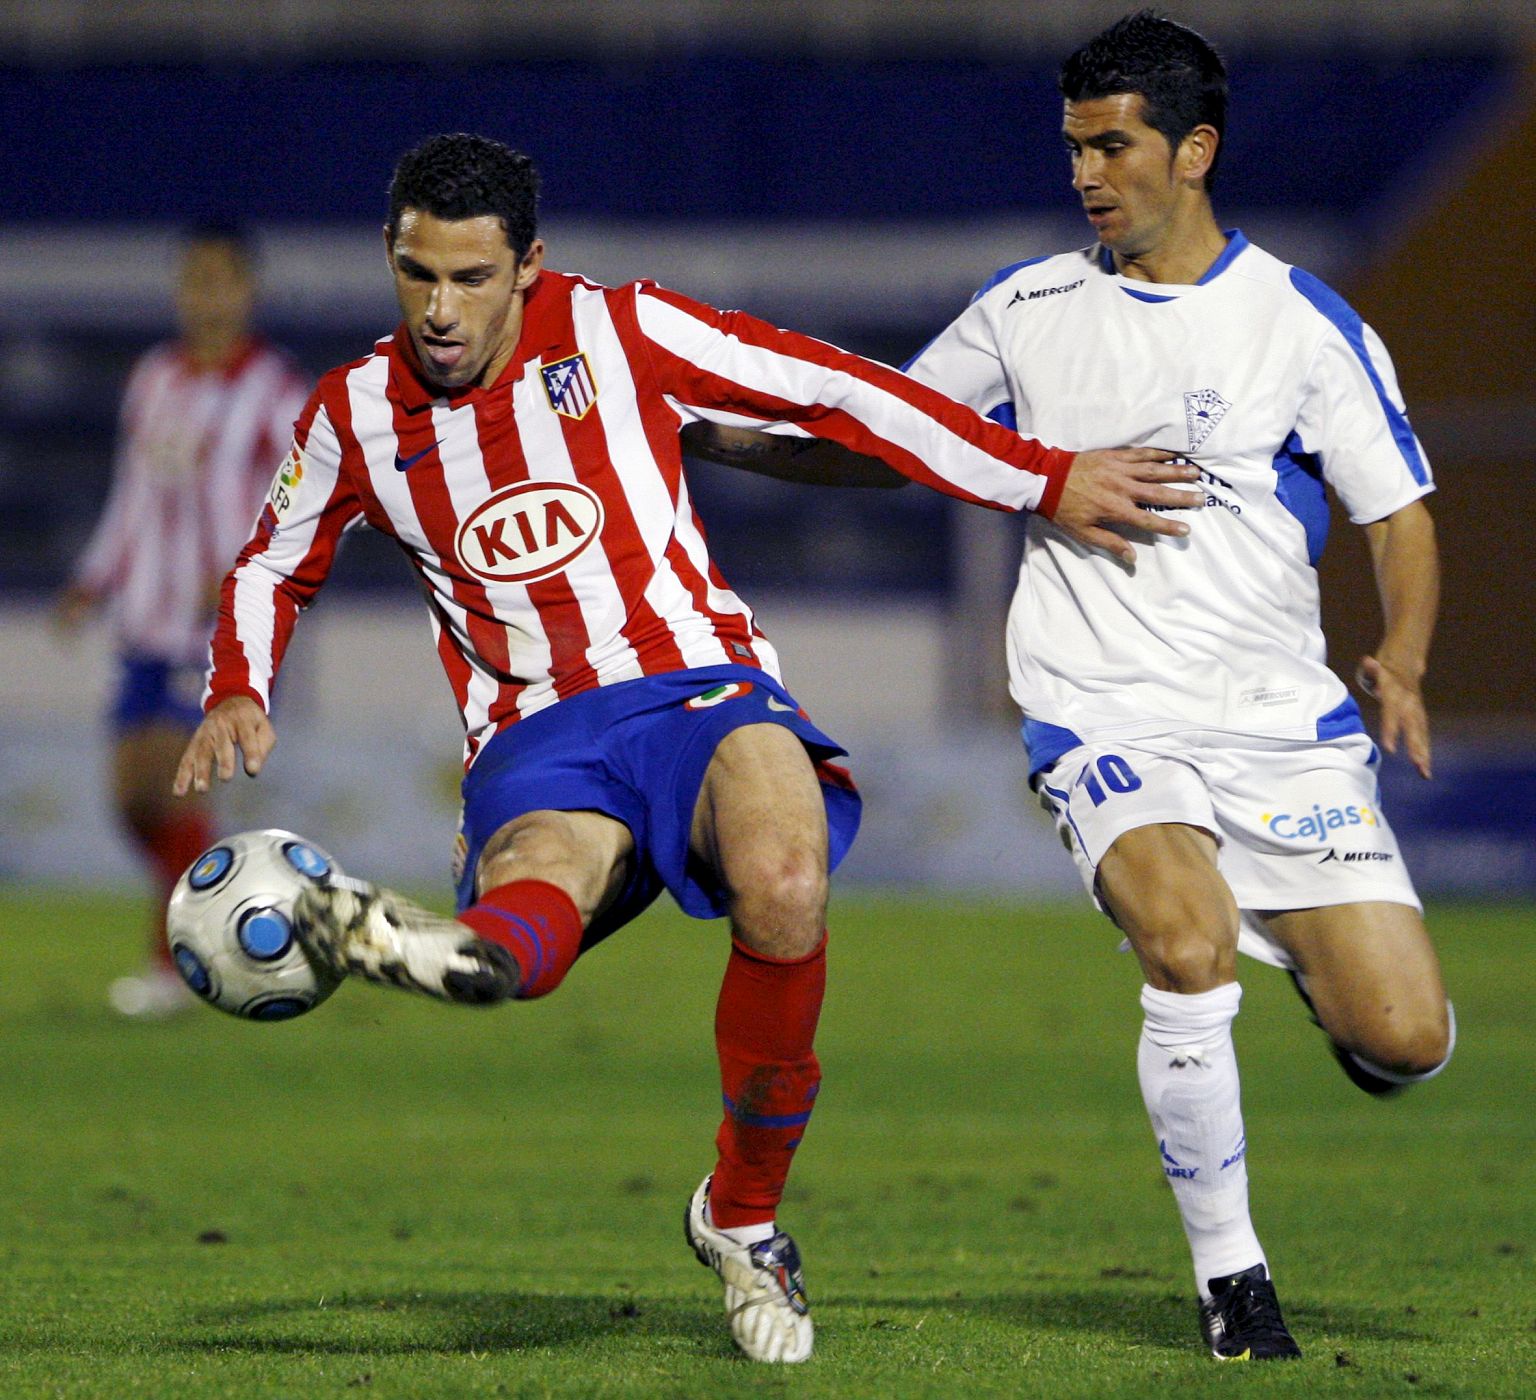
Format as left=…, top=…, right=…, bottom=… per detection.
left=682, top=1177, right=814, bottom=1362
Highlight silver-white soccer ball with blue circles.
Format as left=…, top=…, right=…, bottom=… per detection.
left=166, top=828, right=341, bottom=1020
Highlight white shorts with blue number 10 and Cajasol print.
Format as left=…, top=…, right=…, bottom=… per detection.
left=1035, top=730, right=1422, bottom=968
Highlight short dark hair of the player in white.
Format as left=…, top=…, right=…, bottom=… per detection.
left=1060, top=9, right=1227, bottom=189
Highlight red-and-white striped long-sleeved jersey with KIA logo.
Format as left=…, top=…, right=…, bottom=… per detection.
left=204, top=270, right=1071, bottom=762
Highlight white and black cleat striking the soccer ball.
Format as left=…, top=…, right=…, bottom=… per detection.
left=293, top=876, right=521, bottom=1007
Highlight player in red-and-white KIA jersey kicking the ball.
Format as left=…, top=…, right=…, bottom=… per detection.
left=175, top=134, right=1193, bottom=1362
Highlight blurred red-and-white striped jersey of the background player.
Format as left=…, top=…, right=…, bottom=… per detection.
left=74, top=341, right=307, bottom=664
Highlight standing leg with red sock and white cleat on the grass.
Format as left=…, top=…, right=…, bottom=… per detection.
left=685, top=724, right=828, bottom=1362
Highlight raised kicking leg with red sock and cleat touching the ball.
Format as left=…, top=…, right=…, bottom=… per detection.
left=295, top=810, right=634, bottom=1005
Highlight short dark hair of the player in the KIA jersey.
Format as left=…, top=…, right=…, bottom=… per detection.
left=387, top=132, right=539, bottom=261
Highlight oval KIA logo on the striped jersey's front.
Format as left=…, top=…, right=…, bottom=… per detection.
left=455, top=481, right=602, bottom=584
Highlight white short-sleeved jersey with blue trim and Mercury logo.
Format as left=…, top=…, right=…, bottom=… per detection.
left=908, top=232, right=1433, bottom=771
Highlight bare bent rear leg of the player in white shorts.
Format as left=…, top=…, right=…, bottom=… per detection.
left=1264, top=901, right=1456, bottom=1094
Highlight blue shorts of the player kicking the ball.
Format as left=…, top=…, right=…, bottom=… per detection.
left=456, top=665, right=862, bottom=948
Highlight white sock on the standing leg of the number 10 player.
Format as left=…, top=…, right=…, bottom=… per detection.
left=1137, top=982, right=1267, bottom=1299
